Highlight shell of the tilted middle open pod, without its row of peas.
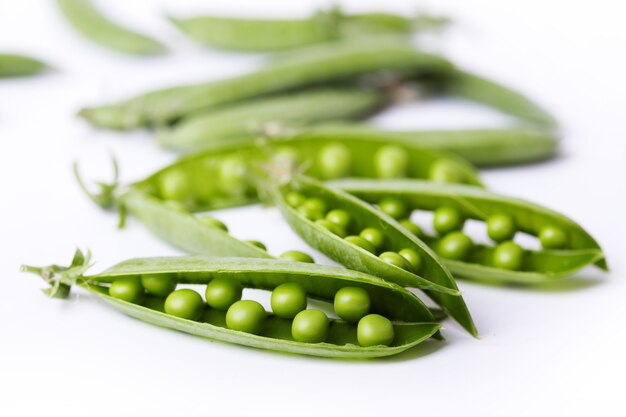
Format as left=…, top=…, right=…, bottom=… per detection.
left=274, top=176, right=477, bottom=336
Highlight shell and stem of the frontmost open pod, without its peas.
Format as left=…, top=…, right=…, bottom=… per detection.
left=22, top=253, right=441, bottom=358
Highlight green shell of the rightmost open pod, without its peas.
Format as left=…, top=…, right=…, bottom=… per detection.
left=331, top=179, right=608, bottom=284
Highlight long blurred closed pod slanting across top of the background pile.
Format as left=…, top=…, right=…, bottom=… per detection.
left=80, top=37, right=452, bottom=129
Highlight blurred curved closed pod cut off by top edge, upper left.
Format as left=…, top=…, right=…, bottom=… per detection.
left=57, top=0, right=165, bottom=55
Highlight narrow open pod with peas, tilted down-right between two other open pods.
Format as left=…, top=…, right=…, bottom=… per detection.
left=274, top=176, right=477, bottom=335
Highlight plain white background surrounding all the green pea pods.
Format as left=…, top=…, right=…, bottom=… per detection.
left=0, top=0, right=626, bottom=416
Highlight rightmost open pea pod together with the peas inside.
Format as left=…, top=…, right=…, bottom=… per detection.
left=331, top=179, right=608, bottom=284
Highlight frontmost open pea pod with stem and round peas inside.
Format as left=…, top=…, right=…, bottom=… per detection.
left=22, top=252, right=441, bottom=358
